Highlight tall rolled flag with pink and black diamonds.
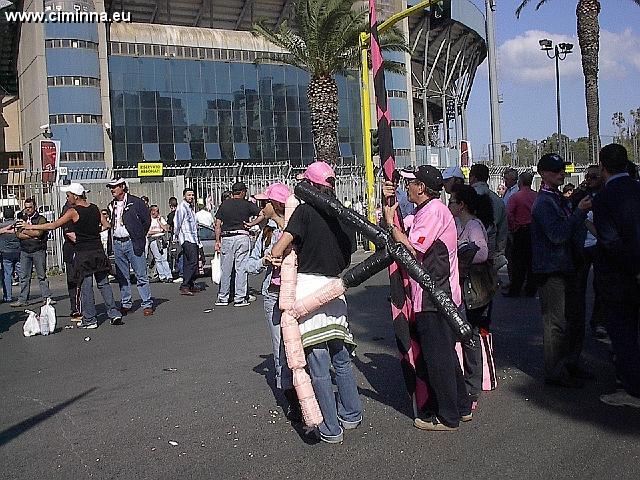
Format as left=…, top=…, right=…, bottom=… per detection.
left=369, top=0, right=428, bottom=413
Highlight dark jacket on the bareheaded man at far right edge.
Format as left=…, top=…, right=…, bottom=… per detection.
left=593, top=177, right=640, bottom=306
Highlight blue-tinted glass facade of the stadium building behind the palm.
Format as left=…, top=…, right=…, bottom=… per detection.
left=109, top=56, right=362, bottom=167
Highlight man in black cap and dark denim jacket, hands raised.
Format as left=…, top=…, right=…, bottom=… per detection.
left=531, top=153, right=591, bottom=388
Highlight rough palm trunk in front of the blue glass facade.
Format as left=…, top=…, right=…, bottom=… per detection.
left=307, top=76, right=339, bottom=165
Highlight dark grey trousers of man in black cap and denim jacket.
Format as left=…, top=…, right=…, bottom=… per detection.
left=539, top=274, right=584, bottom=379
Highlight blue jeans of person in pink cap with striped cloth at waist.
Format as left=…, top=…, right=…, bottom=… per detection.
left=305, top=340, right=362, bottom=436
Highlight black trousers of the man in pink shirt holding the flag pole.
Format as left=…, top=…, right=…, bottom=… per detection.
left=416, top=312, right=471, bottom=427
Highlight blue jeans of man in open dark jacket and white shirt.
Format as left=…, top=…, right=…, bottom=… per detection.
left=112, top=239, right=153, bottom=313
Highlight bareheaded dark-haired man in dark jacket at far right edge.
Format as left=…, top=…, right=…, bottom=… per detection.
left=593, top=143, right=640, bottom=408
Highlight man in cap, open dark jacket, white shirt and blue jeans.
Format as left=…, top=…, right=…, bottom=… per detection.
left=107, top=178, right=153, bottom=317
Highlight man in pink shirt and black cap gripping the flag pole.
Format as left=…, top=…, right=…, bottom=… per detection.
left=383, top=165, right=472, bottom=431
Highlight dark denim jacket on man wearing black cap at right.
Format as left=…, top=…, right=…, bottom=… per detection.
left=531, top=188, right=587, bottom=274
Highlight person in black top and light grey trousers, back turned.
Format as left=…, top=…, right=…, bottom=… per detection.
left=215, top=182, right=260, bottom=307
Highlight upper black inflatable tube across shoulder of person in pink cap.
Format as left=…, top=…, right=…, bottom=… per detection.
left=294, top=182, right=389, bottom=248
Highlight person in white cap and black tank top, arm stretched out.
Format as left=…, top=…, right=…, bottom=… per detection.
left=18, top=183, right=122, bottom=328
